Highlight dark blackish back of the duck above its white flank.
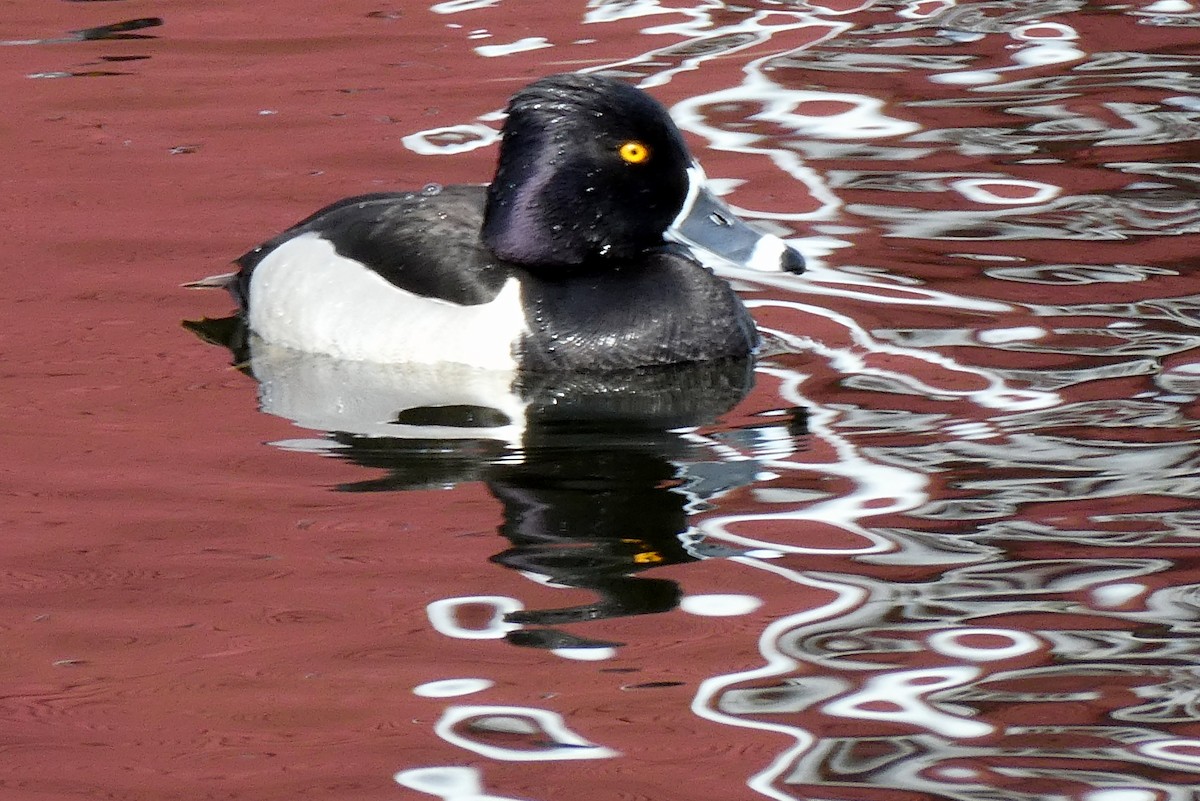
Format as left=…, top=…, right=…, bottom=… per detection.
left=238, top=185, right=512, bottom=306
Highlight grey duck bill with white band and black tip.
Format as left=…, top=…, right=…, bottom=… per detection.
left=666, top=164, right=804, bottom=273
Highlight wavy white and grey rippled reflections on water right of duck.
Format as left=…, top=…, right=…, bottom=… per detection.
left=662, top=2, right=1200, bottom=801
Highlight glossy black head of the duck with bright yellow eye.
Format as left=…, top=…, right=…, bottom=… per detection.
left=484, top=74, right=691, bottom=265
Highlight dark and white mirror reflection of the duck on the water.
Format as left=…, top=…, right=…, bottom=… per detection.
left=188, top=320, right=803, bottom=649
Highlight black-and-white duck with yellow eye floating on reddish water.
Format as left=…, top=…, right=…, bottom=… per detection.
left=190, top=73, right=804, bottom=372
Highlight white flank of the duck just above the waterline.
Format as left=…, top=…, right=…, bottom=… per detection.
left=248, top=234, right=528, bottom=369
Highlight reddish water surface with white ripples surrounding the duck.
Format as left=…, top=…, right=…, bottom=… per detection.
left=7, top=0, right=1200, bottom=801
